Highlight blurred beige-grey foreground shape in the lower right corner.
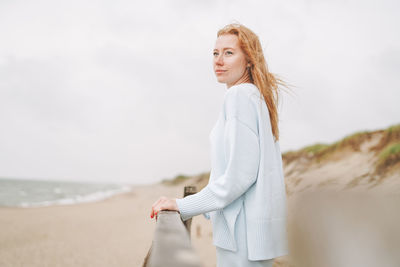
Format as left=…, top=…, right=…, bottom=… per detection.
left=289, top=191, right=400, bottom=267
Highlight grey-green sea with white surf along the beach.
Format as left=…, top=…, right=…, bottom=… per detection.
left=0, top=178, right=132, bottom=208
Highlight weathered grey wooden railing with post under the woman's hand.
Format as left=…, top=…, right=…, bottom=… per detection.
left=143, top=186, right=202, bottom=267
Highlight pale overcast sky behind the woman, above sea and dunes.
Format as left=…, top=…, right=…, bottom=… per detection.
left=0, top=0, right=400, bottom=184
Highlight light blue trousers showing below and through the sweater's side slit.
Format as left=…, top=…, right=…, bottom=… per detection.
left=216, top=203, right=274, bottom=267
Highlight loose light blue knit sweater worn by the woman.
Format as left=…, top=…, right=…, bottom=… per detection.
left=177, top=83, right=288, bottom=260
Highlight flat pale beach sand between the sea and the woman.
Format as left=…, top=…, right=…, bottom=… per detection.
left=0, top=184, right=216, bottom=267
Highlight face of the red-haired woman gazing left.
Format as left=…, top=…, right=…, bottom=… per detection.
left=213, top=34, right=247, bottom=88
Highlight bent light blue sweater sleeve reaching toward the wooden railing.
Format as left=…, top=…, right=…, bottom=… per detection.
left=176, top=117, right=260, bottom=221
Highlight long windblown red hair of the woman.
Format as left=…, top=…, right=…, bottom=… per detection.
left=217, top=23, right=288, bottom=141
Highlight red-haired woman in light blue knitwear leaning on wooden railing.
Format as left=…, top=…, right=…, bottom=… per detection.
left=150, top=24, right=288, bottom=267
